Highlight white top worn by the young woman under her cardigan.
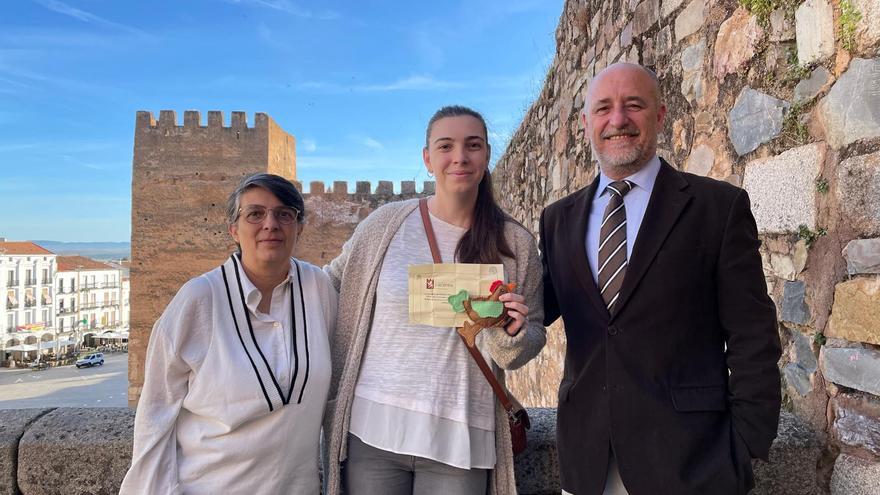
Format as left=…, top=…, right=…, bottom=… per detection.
left=349, top=209, right=495, bottom=469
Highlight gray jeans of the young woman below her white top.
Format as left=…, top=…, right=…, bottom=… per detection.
left=342, top=433, right=489, bottom=495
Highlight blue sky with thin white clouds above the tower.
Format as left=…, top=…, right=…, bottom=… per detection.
left=0, top=0, right=564, bottom=241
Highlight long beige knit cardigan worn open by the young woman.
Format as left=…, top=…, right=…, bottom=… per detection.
left=324, top=199, right=546, bottom=495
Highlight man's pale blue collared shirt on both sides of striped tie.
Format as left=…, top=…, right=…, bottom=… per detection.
left=586, top=155, right=660, bottom=284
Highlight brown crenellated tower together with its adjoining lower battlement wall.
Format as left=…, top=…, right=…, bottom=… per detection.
left=128, top=110, right=434, bottom=406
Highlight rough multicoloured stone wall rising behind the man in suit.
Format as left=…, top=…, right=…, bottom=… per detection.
left=495, top=0, right=880, bottom=484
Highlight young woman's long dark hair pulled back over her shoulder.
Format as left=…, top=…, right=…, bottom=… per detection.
left=425, top=105, right=513, bottom=263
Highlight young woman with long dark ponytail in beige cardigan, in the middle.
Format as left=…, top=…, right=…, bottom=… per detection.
left=324, top=106, right=545, bottom=495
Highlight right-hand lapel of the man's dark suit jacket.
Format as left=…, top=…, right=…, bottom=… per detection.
left=608, top=158, right=691, bottom=318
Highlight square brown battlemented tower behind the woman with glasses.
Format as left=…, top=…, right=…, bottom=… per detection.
left=128, top=110, right=296, bottom=401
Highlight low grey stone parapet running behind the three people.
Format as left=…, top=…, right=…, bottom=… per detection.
left=0, top=408, right=824, bottom=495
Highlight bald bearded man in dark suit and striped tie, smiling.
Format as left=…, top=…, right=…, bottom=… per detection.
left=540, top=64, right=781, bottom=495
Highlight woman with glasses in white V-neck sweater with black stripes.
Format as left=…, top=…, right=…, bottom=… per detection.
left=120, top=173, right=337, bottom=495
